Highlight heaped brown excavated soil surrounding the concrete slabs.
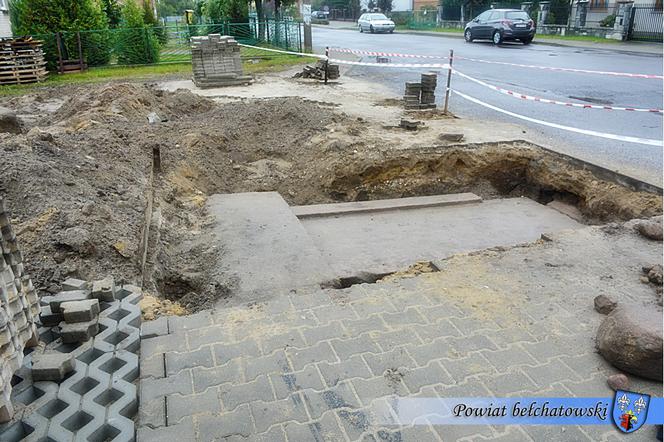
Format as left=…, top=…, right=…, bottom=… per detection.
left=0, top=80, right=662, bottom=312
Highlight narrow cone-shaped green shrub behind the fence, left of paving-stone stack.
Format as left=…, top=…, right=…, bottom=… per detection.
left=115, top=1, right=160, bottom=64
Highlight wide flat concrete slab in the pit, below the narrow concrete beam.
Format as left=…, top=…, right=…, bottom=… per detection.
left=301, top=198, right=582, bottom=277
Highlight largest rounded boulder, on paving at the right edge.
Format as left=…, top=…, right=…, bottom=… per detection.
left=596, top=305, right=662, bottom=382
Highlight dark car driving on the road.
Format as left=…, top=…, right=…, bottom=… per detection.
left=463, top=9, right=535, bottom=45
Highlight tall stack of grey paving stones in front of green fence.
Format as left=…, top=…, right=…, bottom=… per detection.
left=191, top=34, right=252, bottom=88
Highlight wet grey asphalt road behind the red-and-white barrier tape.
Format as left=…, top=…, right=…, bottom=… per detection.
left=313, top=27, right=663, bottom=186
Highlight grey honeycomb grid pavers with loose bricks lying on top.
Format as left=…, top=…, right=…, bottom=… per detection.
left=0, top=278, right=143, bottom=442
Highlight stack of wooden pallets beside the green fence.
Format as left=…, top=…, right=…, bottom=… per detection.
left=0, top=37, right=47, bottom=85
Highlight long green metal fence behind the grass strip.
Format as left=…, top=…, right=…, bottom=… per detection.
left=3, top=19, right=303, bottom=72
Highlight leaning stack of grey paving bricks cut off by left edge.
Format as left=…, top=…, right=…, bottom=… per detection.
left=0, top=197, right=40, bottom=422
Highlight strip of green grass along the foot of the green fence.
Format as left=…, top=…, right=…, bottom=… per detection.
left=0, top=55, right=316, bottom=96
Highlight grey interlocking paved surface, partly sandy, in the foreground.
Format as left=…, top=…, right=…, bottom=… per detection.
left=138, top=228, right=662, bottom=442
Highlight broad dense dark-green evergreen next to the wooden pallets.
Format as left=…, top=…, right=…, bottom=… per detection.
left=9, top=0, right=111, bottom=68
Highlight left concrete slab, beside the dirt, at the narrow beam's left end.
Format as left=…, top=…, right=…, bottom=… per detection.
left=208, top=192, right=332, bottom=300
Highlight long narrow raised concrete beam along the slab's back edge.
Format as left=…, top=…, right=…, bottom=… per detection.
left=291, top=193, right=482, bottom=219
